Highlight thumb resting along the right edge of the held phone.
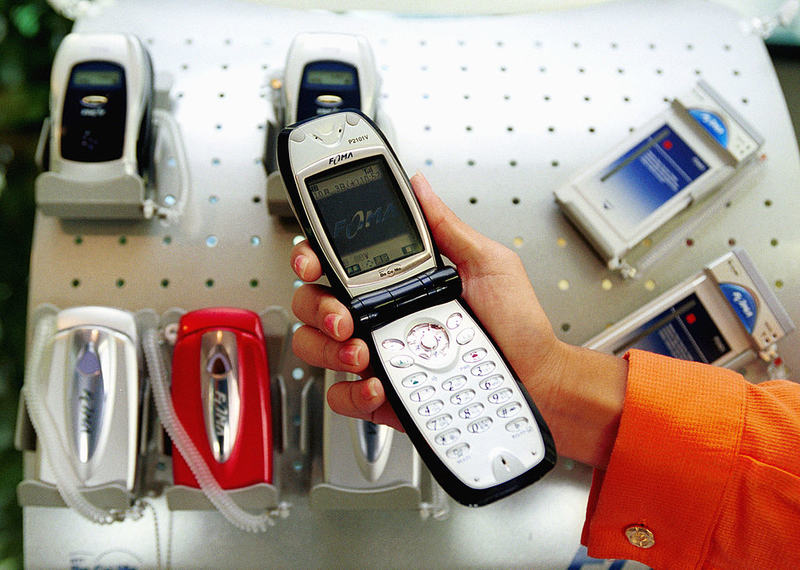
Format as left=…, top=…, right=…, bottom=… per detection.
left=411, top=171, right=490, bottom=267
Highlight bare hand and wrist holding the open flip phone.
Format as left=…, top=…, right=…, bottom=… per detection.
left=291, top=170, right=627, bottom=464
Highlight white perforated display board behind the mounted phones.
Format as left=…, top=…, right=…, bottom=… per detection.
left=25, top=0, right=800, bottom=570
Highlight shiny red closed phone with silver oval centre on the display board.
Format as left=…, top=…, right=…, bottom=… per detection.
left=172, top=308, right=272, bottom=489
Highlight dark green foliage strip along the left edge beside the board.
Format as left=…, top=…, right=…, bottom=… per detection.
left=0, top=0, right=72, bottom=570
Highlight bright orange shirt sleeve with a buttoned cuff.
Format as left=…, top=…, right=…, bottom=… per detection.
left=582, top=351, right=800, bottom=570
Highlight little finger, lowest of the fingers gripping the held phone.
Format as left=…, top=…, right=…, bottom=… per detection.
left=328, top=378, right=403, bottom=431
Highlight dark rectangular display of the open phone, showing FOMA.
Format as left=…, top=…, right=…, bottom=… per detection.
left=306, top=156, right=424, bottom=277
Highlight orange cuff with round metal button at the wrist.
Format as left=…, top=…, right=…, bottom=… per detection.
left=581, top=350, right=746, bottom=568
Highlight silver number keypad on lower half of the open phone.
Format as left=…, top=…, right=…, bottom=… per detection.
left=376, top=303, right=535, bottom=480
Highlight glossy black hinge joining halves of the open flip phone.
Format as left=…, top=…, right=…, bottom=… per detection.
left=350, top=266, right=461, bottom=330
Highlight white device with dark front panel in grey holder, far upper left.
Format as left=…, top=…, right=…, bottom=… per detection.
left=36, top=33, right=154, bottom=219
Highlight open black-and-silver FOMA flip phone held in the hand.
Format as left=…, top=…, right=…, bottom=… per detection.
left=278, top=111, right=556, bottom=506
